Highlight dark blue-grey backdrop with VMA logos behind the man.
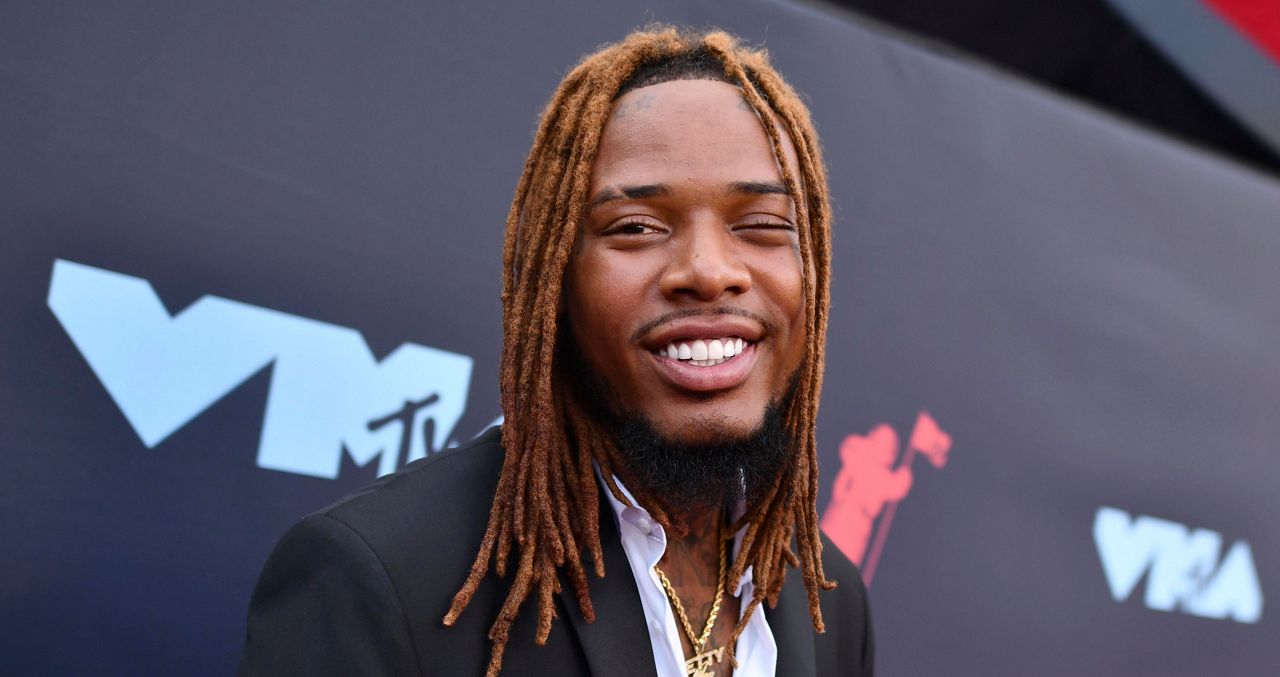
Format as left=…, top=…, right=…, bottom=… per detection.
left=0, top=0, right=1280, bottom=676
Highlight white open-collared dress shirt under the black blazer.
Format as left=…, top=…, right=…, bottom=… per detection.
left=596, top=468, right=778, bottom=677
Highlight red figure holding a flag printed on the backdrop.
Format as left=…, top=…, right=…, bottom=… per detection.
left=820, top=411, right=951, bottom=586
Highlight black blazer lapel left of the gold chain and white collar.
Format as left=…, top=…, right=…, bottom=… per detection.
left=561, top=491, right=660, bottom=677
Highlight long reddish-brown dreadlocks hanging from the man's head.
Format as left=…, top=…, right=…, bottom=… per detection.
left=444, top=27, right=835, bottom=676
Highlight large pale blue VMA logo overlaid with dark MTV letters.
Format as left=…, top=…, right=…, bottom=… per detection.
left=49, top=260, right=472, bottom=479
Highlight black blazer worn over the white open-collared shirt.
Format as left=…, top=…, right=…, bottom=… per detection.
left=239, top=427, right=873, bottom=677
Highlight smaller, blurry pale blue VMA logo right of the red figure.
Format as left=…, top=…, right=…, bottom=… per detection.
left=1093, top=507, right=1262, bottom=623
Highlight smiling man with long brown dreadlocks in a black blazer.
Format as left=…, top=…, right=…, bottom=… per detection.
left=241, top=29, right=872, bottom=676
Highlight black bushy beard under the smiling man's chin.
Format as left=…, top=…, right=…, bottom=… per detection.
left=616, top=402, right=790, bottom=516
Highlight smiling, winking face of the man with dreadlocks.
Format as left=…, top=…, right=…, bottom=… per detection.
left=566, top=81, right=805, bottom=444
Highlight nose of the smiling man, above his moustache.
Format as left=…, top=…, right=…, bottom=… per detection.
left=659, top=219, right=751, bottom=301
